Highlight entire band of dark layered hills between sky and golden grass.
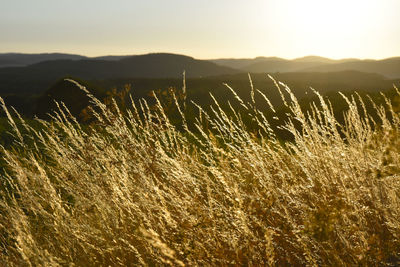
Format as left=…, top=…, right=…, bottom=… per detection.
left=0, top=53, right=400, bottom=119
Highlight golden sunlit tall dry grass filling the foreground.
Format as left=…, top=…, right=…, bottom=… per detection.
left=0, top=78, right=400, bottom=266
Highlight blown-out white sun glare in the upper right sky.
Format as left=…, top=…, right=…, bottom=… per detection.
left=268, top=0, right=386, bottom=58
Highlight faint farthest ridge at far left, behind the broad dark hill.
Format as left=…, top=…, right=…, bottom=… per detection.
left=0, top=53, right=86, bottom=67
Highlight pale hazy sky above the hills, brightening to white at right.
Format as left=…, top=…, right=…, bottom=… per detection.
left=0, top=0, right=400, bottom=59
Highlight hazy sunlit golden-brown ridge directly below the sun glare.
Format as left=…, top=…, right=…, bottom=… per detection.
left=211, top=56, right=400, bottom=79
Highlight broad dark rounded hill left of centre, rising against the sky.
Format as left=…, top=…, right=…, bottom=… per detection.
left=0, top=53, right=239, bottom=95
